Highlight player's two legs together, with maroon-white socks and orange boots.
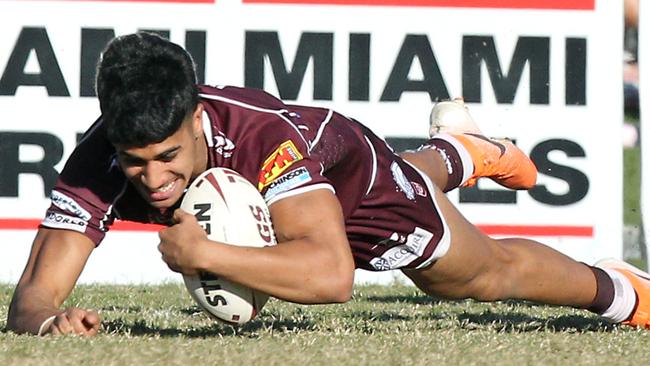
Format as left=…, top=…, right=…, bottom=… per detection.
left=402, top=102, right=650, bottom=328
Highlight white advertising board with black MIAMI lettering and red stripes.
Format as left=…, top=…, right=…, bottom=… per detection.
left=0, top=0, right=623, bottom=282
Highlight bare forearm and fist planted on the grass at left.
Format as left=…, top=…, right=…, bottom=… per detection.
left=7, top=228, right=100, bottom=336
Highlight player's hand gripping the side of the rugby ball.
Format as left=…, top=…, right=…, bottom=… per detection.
left=158, top=208, right=207, bottom=275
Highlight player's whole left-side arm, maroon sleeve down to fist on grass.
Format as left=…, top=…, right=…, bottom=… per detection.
left=7, top=120, right=127, bottom=336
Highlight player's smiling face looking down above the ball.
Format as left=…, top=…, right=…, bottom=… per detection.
left=116, top=105, right=207, bottom=208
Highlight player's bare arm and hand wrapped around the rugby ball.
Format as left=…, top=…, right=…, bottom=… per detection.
left=159, top=189, right=354, bottom=304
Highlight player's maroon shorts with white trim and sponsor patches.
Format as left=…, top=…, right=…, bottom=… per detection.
left=346, top=134, right=451, bottom=271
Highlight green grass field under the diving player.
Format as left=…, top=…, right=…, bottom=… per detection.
left=0, top=284, right=650, bottom=366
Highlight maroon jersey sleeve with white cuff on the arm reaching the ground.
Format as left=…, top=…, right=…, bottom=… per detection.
left=41, top=121, right=127, bottom=245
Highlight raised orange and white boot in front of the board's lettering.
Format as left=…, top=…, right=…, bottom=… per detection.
left=429, top=99, right=537, bottom=189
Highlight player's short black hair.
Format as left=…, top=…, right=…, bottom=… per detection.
left=96, top=32, right=199, bottom=147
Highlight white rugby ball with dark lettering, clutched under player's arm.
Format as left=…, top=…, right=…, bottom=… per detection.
left=181, top=168, right=275, bottom=325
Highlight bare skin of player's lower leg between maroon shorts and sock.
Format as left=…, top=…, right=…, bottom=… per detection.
left=404, top=184, right=596, bottom=307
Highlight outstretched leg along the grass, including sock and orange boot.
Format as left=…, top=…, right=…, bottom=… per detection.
left=403, top=184, right=650, bottom=328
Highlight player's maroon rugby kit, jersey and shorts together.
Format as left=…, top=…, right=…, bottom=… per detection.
left=42, top=86, right=449, bottom=270
